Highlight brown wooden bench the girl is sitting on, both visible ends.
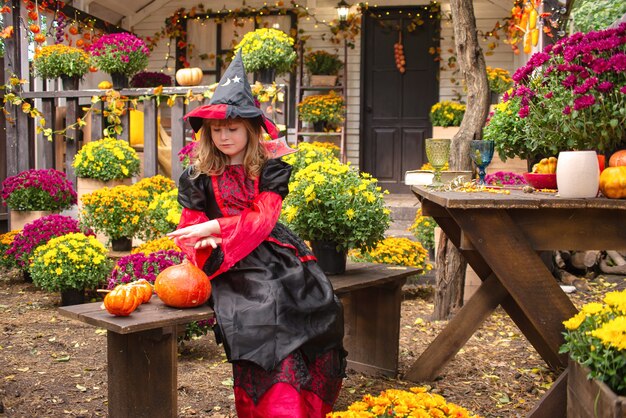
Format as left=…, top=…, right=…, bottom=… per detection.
left=59, top=263, right=419, bottom=418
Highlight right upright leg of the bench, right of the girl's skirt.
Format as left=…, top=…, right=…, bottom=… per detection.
left=339, top=278, right=406, bottom=377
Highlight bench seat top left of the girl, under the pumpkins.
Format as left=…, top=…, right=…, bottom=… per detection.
left=59, top=295, right=213, bottom=334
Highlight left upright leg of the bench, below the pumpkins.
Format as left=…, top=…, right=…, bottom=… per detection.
left=107, top=328, right=178, bottom=418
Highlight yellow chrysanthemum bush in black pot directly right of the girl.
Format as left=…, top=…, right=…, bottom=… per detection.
left=281, top=159, right=391, bottom=274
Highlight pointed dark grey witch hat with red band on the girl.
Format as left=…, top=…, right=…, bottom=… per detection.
left=183, top=50, right=279, bottom=138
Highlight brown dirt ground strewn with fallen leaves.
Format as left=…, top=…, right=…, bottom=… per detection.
left=0, top=271, right=626, bottom=418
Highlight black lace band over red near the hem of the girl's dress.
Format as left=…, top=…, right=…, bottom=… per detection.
left=233, top=349, right=347, bottom=405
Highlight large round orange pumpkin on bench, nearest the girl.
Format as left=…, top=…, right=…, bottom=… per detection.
left=154, top=260, right=211, bottom=308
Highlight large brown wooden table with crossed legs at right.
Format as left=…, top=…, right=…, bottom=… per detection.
left=405, top=186, right=626, bottom=417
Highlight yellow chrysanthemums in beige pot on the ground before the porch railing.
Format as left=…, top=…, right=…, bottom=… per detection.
left=72, top=138, right=141, bottom=209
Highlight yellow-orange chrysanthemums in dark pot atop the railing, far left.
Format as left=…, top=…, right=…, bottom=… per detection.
left=33, top=44, right=91, bottom=90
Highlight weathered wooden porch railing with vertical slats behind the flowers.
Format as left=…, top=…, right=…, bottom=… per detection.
left=11, top=86, right=207, bottom=185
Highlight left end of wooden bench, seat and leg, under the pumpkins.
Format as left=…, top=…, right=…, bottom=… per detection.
left=59, top=296, right=213, bottom=418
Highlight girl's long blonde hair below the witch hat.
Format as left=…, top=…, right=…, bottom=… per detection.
left=191, top=118, right=267, bottom=178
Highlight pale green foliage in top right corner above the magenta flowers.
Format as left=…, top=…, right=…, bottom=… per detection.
left=572, top=0, right=626, bottom=32
